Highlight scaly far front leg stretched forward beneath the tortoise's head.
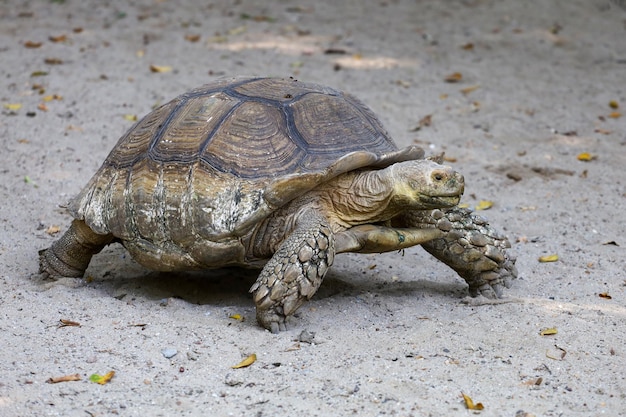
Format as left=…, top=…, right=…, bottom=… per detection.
left=397, top=207, right=517, bottom=298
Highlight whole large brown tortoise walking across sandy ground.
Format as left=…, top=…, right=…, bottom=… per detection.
left=40, top=77, right=517, bottom=332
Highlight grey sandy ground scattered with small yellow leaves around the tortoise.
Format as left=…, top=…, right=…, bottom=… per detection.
left=0, top=0, right=626, bottom=417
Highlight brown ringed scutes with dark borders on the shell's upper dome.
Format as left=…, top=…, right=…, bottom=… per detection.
left=105, top=78, right=396, bottom=178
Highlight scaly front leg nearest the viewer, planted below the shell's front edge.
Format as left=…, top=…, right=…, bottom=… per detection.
left=250, top=210, right=335, bottom=333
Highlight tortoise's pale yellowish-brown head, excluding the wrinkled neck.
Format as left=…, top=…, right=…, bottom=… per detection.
left=389, top=159, right=465, bottom=210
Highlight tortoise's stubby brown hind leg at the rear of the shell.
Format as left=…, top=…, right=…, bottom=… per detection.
left=39, top=220, right=113, bottom=278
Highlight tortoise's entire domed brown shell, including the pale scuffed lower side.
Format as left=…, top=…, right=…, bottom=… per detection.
left=68, top=78, right=423, bottom=264
